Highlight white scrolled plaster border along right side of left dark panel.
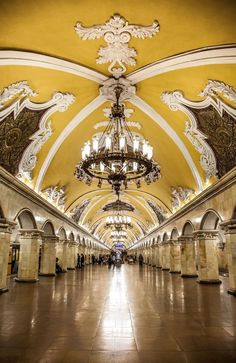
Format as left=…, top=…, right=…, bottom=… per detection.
left=18, top=92, right=75, bottom=181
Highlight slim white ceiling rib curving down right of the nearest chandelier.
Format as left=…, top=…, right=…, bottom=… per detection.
left=130, top=96, right=203, bottom=191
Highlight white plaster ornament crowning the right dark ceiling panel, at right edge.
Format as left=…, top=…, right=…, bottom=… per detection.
left=199, top=79, right=236, bottom=102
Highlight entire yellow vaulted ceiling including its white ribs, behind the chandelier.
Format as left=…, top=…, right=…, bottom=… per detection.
left=0, top=0, right=236, bottom=249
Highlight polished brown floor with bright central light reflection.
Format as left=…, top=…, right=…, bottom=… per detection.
left=0, top=265, right=236, bottom=363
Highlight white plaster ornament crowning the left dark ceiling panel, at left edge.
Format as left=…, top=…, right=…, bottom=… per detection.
left=0, top=81, right=37, bottom=108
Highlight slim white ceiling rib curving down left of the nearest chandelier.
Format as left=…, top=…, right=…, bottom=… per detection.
left=35, top=96, right=106, bottom=193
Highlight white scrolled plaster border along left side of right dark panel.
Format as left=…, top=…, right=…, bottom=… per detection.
left=161, top=91, right=217, bottom=180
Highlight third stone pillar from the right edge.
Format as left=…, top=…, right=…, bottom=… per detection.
left=178, top=236, right=198, bottom=277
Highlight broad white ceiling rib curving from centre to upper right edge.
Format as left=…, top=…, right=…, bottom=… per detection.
left=126, top=44, right=236, bottom=84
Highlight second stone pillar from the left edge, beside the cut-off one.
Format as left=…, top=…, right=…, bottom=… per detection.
left=15, top=229, right=42, bottom=282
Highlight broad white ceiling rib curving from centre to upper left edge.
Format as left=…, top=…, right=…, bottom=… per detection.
left=0, top=50, right=107, bottom=84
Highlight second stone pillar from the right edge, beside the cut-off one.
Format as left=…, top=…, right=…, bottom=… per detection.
left=194, top=230, right=221, bottom=284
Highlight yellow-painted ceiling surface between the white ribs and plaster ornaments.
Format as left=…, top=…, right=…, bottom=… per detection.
left=0, top=0, right=236, bottom=247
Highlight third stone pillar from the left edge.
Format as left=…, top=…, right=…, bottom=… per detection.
left=39, top=235, right=58, bottom=276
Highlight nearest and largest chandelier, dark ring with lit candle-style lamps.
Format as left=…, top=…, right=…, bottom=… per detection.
left=75, top=84, right=160, bottom=194
